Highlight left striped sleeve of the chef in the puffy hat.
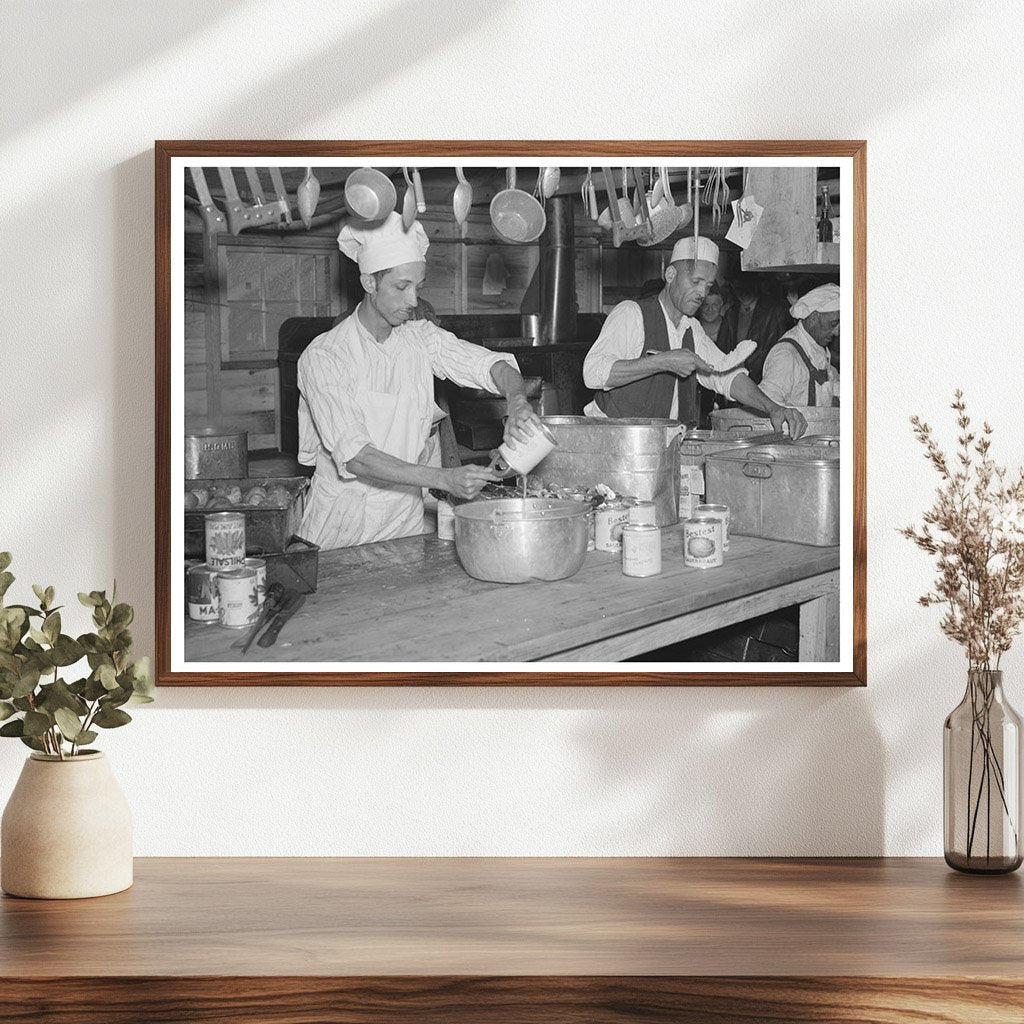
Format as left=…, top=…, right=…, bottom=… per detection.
left=298, top=349, right=373, bottom=479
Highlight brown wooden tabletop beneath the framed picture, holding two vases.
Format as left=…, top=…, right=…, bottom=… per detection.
left=0, top=858, right=1024, bottom=1024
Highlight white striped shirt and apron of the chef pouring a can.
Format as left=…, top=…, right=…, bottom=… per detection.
left=298, top=307, right=518, bottom=549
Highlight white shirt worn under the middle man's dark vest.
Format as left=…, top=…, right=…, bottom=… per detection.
left=583, top=299, right=746, bottom=419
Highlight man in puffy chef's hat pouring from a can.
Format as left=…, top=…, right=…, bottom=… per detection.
left=298, top=213, right=539, bottom=549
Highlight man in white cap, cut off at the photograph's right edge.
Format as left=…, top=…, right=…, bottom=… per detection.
left=761, top=285, right=839, bottom=406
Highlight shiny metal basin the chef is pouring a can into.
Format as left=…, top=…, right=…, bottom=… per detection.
left=455, top=498, right=590, bottom=583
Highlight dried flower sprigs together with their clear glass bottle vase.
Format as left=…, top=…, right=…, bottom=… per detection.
left=900, top=390, right=1024, bottom=872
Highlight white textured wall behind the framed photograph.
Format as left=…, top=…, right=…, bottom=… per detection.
left=0, top=0, right=1024, bottom=855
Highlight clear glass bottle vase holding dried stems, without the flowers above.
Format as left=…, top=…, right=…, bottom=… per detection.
left=942, top=669, right=1022, bottom=874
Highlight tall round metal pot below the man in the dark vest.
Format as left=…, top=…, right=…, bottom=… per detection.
left=529, top=416, right=681, bottom=526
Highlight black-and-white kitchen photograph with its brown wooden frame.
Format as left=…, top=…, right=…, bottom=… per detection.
left=156, top=141, right=866, bottom=686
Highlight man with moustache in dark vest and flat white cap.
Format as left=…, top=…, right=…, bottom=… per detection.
left=583, top=236, right=807, bottom=437
